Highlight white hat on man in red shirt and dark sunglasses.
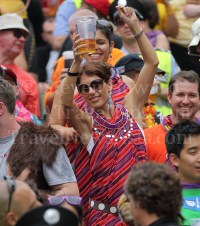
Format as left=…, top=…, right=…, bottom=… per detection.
left=0, top=13, right=30, bottom=36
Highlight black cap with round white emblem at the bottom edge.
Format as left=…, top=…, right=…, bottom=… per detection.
left=15, top=206, right=78, bottom=226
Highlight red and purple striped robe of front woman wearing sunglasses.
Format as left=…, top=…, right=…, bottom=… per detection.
left=85, top=105, right=147, bottom=226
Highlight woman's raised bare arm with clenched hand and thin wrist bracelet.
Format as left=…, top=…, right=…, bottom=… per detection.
left=117, top=6, right=159, bottom=126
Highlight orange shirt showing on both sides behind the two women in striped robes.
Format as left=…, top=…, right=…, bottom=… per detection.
left=44, top=48, right=125, bottom=108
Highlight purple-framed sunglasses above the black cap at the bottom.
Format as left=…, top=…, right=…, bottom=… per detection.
left=48, top=196, right=82, bottom=205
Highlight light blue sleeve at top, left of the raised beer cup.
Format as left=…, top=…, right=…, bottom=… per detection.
left=53, top=0, right=76, bottom=36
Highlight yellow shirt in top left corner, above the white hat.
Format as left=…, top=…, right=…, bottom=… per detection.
left=0, top=0, right=28, bottom=19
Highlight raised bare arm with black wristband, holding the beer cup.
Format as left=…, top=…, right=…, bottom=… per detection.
left=61, top=35, right=92, bottom=146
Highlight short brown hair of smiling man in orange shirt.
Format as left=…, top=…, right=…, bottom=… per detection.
left=168, top=70, right=200, bottom=95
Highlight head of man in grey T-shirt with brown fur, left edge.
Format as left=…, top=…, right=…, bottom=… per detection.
left=0, top=78, right=16, bottom=117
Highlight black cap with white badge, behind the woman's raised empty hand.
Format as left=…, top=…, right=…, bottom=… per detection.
left=109, top=0, right=147, bottom=24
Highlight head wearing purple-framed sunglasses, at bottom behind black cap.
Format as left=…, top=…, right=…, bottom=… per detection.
left=48, top=196, right=83, bottom=226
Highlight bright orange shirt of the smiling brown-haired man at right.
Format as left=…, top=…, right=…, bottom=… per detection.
left=144, top=124, right=167, bottom=162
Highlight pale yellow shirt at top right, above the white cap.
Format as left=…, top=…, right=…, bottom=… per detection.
left=169, top=0, right=198, bottom=48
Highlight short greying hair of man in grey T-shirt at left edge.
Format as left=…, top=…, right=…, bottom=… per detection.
left=0, top=78, right=16, bottom=114
